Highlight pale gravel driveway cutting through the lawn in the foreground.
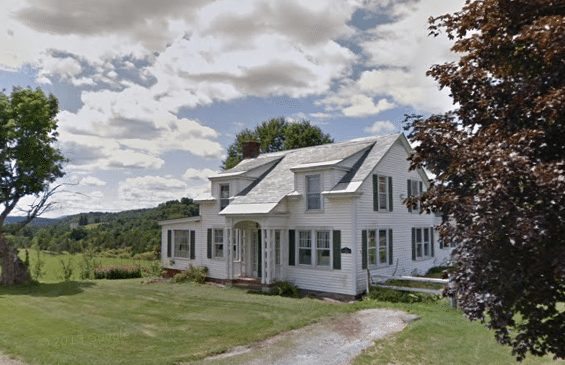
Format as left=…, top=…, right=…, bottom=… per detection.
left=192, top=309, right=418, bottom=365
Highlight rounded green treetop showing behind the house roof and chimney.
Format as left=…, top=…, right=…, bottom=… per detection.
left=222, top=118, right=333, bottom=170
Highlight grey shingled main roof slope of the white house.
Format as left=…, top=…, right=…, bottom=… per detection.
left=222, top=134, right=400, bottom=214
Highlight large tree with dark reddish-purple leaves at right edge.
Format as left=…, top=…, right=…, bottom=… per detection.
left=408, top=0, right=565, bottom=359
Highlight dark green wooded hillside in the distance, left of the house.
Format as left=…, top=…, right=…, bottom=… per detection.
left=10, top=198, right=198, bottom=254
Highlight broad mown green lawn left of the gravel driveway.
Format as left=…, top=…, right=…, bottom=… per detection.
left=0, top=280, right=355, bottom=364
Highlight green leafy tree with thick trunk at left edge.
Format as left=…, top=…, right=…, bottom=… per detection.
left=0, top=88, right=65, bottom=285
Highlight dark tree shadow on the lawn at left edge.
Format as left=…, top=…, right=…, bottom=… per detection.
left=0, top=281, right=96, bottom=298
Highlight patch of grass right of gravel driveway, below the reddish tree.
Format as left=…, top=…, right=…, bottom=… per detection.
left=354, top=300, right=565, bottom=365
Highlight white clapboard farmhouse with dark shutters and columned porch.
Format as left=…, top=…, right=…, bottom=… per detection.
left=160, top=134, right=450, bottom=296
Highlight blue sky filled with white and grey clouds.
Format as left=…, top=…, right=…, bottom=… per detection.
left=0, top=0, right=462, bottom=217
